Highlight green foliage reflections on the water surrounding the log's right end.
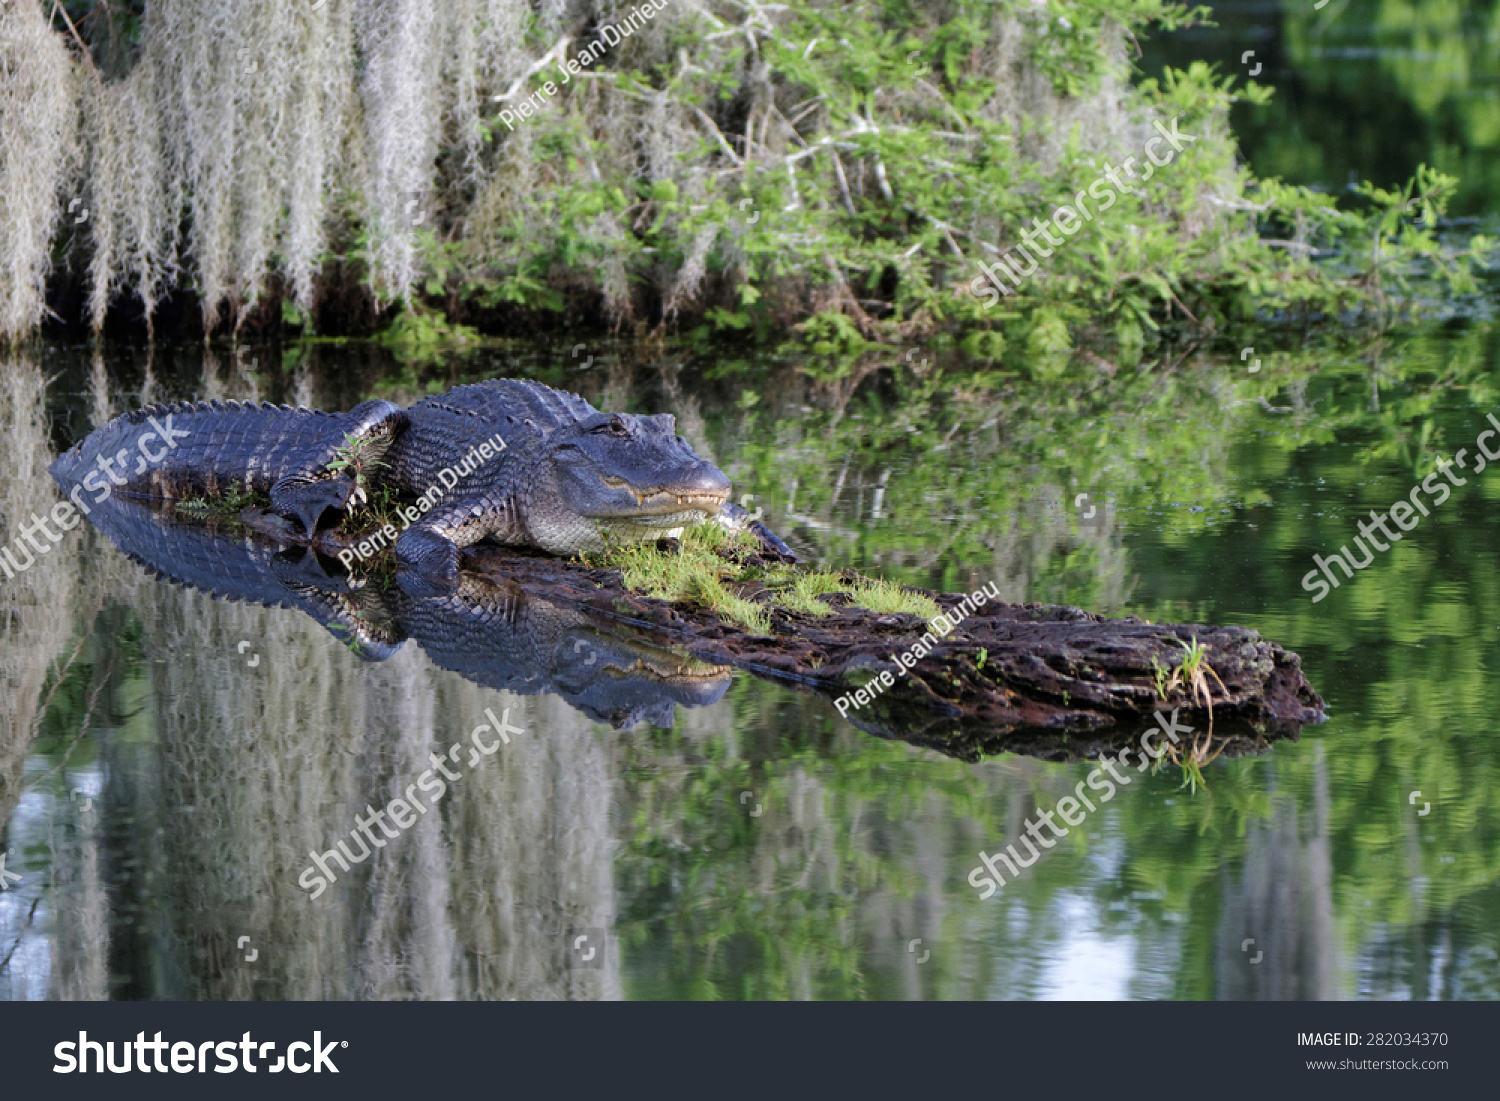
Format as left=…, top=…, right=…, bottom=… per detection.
left=603, top=326, right=1500, bottom=998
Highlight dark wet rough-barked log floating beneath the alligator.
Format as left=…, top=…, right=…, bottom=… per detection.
left=447, top=548, right=1323, bottom=759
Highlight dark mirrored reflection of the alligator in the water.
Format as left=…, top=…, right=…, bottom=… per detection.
left=90, top=498, right=732, bottom=729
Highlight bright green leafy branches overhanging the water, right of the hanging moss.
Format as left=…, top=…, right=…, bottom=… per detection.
left=438, top=0, right=1487, bottom=358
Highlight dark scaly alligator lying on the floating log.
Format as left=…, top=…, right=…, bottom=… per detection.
left=51, top=378, right=795, bottom=585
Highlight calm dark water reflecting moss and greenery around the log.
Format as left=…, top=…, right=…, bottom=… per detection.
left=0, top=0, right=1500, bottom=999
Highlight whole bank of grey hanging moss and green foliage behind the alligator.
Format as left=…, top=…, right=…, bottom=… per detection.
left=0, top=0, right=1488, bottom=351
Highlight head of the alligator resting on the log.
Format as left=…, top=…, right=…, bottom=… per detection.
left=540, top=413, right=731, bottom=552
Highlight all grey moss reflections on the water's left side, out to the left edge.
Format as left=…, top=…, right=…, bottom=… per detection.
left=0, top=355, right=633, bottom=999
